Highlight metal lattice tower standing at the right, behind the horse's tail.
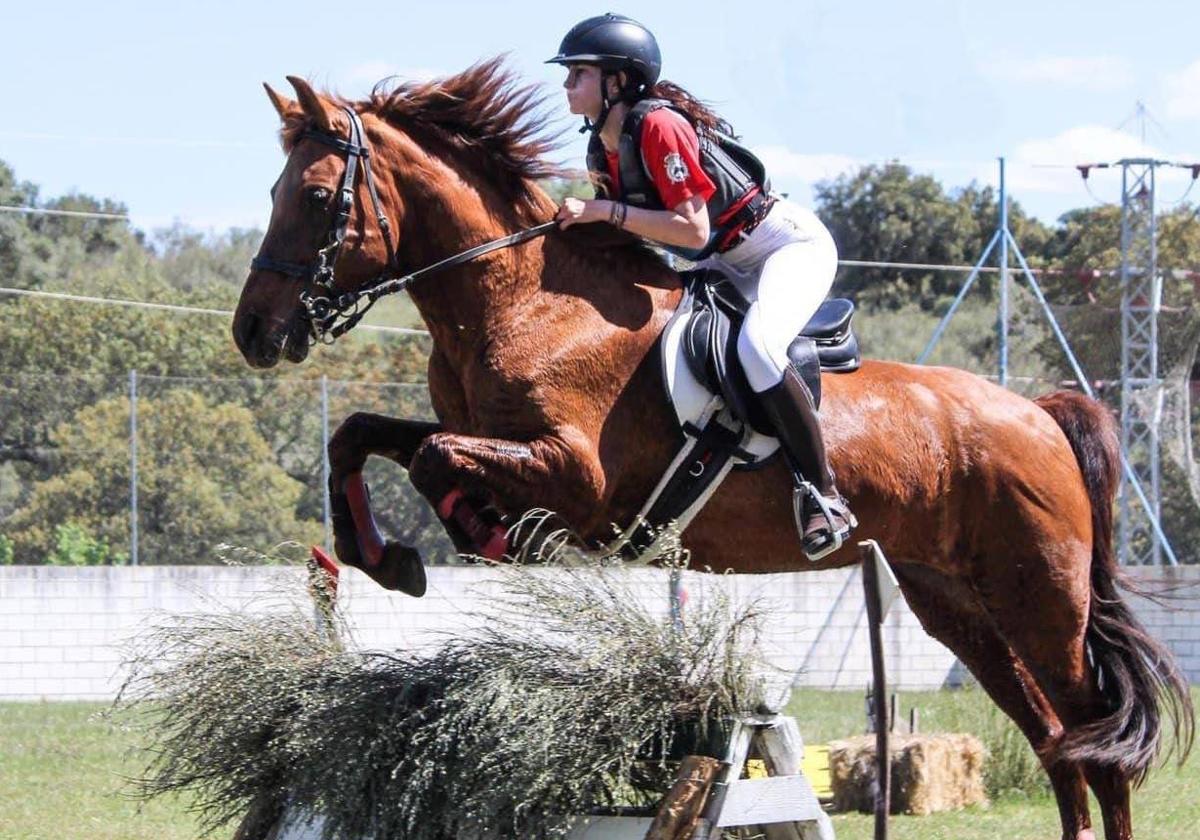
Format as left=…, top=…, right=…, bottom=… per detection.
left=1117, top=158, right=1163, bottom=565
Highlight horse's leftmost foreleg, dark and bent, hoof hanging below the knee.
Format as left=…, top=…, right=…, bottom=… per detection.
left=329, top=412, right=442, bottom=595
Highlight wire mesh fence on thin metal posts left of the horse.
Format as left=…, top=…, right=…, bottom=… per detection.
left=0, top=371, right=456, bottom=564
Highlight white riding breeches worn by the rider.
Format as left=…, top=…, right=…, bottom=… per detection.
left=700, top=198, right=838, bottom=391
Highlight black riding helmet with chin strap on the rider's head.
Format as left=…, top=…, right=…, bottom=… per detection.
left=546, top=12, right=662, bottom=133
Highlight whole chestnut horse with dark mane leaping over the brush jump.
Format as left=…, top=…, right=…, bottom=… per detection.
left=233, top=60, right=1193, bottom=840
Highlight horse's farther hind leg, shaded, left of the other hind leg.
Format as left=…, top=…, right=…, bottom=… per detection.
left=894, top=563, right=1094, bottom=840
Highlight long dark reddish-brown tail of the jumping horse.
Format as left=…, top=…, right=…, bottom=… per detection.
left=1036, top=391, right=1195, bottom=785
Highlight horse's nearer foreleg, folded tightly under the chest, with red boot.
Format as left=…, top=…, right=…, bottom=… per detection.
left=409, top=430, right=604, bottom=559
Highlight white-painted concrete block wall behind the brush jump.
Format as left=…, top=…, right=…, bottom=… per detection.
left=0, top=566, right=1200, bottom=700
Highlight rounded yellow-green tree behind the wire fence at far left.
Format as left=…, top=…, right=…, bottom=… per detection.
left=5, top=390, right=322, bottom=563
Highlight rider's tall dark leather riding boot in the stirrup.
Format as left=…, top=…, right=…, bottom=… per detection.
left=758, top=367, right=858, bottom=560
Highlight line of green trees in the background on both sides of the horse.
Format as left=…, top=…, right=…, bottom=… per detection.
left=7, top=162, right=1200, bottom=564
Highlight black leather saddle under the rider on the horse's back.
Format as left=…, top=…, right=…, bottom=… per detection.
left=679, top=269, right=863, bottom=436
